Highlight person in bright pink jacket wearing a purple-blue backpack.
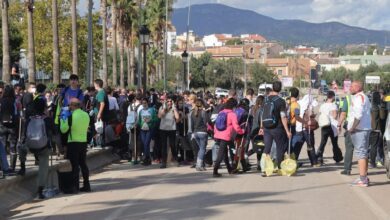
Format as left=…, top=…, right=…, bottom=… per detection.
left=213, top=98, right=245, bottom=177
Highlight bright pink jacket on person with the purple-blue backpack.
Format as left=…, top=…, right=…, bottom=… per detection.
left=214, top=109, right=245, bottom=141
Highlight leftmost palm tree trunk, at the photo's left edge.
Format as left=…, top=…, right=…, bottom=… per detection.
left=1, top=0, right=10, bottom=83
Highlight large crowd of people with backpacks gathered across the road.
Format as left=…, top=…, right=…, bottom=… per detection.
left=0, top=75, right=387, bottom=199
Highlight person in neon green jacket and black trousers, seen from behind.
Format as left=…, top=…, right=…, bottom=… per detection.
left=61, top=98, right=91, bottom=193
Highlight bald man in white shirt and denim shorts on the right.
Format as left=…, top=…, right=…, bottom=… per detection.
left=348, top=81, right=371, bottom=187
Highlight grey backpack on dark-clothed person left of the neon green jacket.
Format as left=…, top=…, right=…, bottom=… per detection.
left=26, top=116, right=49, bottom=150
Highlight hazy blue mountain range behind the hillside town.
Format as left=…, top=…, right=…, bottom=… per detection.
left=172, top=4, right=390, bottom=47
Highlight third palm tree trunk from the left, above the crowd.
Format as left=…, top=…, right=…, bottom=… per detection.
left=51, top=0, right=60, bottom=85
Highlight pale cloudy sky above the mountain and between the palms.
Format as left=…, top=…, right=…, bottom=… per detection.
left=78, top=0, right=390, bottom=30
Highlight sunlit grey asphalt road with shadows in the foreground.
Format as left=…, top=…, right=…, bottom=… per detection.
left=9, top=131, right=390, bottom=220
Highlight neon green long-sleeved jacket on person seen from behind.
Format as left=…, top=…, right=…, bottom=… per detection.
left=60, top=109, right=89, bottom=143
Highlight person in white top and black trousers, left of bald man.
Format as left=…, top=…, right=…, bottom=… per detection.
left=316, top=91, right=343, bottom=164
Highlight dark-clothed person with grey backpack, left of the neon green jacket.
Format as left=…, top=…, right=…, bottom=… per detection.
left=25, top=84, right=54, bottom=199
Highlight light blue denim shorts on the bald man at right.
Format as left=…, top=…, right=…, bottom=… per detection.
left=351, top=131, right=371, bottom=160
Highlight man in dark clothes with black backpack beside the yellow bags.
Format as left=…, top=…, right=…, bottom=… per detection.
left=262, top=81, right=291, bottom=168
